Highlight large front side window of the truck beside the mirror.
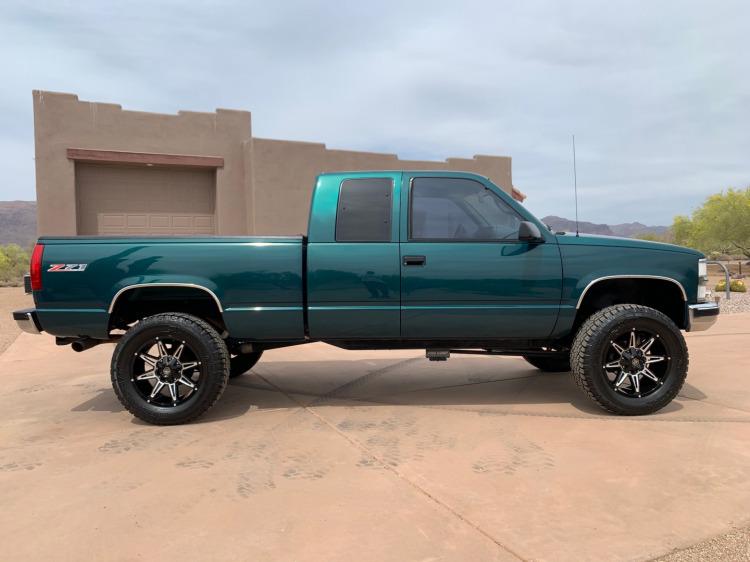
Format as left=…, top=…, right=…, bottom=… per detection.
left=409, top=178, right=523, bottom=240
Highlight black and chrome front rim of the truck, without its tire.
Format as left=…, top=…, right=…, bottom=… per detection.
left=602, top=327, right=672, bottom=398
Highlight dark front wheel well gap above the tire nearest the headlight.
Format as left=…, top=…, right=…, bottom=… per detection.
left=573, top=278, right=687, bottom=333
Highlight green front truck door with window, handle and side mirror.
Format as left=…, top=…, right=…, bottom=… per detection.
left=401, top=173, right=562, bottom=339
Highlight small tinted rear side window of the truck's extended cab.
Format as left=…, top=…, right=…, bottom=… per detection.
left=336, top=178, right=393, bottom=242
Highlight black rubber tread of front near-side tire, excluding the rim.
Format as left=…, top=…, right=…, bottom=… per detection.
left=570, top=304, right=688, bottom=416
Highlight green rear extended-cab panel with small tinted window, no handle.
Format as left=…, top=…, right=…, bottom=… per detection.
left=307, top=172, right=401, bottom=340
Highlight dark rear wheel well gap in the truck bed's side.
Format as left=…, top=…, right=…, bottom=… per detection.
left=109, top=286, right=226, bottom=333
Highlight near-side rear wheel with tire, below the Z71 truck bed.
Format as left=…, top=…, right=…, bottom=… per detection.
left=112, top=313, right=229, bottom=425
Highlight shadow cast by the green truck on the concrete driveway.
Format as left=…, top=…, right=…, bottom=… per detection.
left=71, top=358, right=706, bottom=424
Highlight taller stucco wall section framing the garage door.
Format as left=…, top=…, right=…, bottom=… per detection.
left=33, top=91, right=251, bottom=235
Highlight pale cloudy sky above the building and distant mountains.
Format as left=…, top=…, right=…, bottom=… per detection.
left=0, top=0, right=750, bottom=225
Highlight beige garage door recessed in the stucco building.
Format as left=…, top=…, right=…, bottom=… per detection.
left=76, top=163, right=216, bottom=235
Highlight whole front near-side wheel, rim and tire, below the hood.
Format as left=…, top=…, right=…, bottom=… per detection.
left=570, top=304, right=688, bottom=416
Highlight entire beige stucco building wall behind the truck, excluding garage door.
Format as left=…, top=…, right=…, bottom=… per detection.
left=33, top=91, right=518, bottom=235
